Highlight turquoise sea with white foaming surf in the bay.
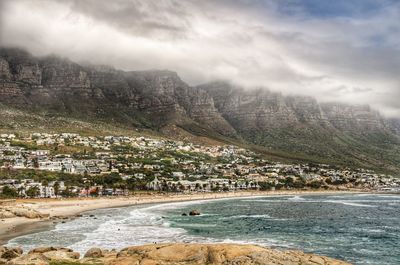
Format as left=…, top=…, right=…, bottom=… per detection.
left=10, top=194, right=400, bottom=265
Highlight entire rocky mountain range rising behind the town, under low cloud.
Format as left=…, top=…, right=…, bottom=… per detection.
left=0, top=48, right=400, bottom=171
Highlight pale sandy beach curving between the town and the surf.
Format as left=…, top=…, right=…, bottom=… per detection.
left=0, top=190, right=362, bottom=245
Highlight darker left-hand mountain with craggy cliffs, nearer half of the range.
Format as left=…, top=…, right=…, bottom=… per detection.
left=0, top=46, right=235, bottom=135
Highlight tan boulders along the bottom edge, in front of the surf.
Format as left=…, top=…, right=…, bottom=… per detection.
left=0, top=244, right=349, bottom=265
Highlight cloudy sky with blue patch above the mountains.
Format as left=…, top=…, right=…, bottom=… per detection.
left=0, top=0, right=400, bottom=117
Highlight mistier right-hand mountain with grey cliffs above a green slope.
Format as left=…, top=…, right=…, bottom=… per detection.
left=199, top=82, right=400, bottom=171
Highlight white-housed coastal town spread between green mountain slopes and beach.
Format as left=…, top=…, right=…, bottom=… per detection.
left=0, top=133, right=400, bottom=198
